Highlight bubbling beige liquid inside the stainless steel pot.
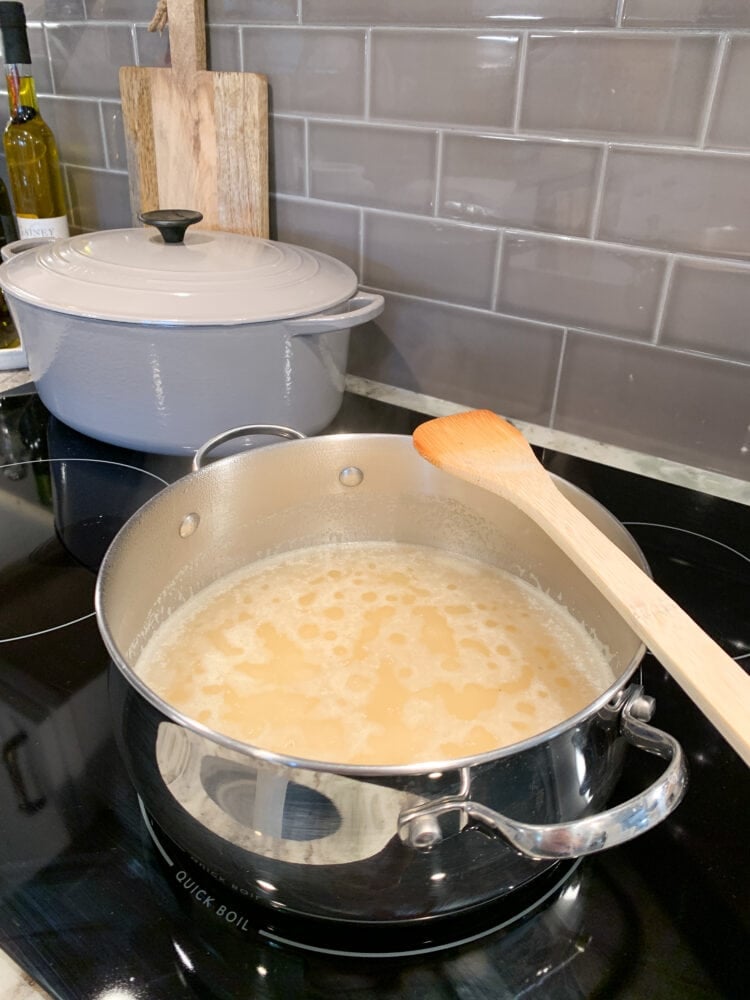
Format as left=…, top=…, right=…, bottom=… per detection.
left=136, top=542, right=614, bottom=765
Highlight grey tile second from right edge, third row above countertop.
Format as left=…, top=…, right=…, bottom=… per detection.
left=440, top=132, right=602, bottom=236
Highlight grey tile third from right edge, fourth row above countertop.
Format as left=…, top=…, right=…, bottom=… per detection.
left=370, top=30, right=519, bottom=128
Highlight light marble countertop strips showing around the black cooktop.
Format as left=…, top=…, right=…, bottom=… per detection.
left=0, top=369, right=750, bottom=1000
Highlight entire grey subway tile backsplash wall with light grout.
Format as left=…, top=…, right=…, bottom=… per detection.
left=5, top=0, right=750, bottom=478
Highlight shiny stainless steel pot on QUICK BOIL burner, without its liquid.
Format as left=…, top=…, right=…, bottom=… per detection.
left=96, top=431, right=686, bottom=922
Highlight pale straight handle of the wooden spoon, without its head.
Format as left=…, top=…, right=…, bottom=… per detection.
left=523, top=479, right=750, bottom=764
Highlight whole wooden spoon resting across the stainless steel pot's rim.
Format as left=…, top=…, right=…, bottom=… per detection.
left=413, top=410, right=750, bottom=764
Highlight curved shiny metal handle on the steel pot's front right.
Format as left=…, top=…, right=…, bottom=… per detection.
left=399, top=685, right=687, bottom=860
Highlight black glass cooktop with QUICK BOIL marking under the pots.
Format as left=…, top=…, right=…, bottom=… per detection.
left=0, top=389, right=750, bottom=1000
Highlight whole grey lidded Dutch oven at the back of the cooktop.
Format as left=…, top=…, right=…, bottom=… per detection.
left=0, top=211, right=383, bottom=454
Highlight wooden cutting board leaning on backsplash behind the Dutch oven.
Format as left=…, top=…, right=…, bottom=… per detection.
left=120, top=0, right=268, bottom=237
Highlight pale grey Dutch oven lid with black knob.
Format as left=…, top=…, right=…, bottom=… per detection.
left=0, top=210, right=357, bottom=326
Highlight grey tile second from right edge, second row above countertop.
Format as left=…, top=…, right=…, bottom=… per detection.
left=497, top=232, right=666, bottom=340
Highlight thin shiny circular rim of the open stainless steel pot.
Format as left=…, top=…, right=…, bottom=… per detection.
left=94, top=433, right=651, bottom=778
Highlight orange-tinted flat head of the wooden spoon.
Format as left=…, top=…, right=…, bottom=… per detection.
left=412, top=410, right=547, bottom=494
